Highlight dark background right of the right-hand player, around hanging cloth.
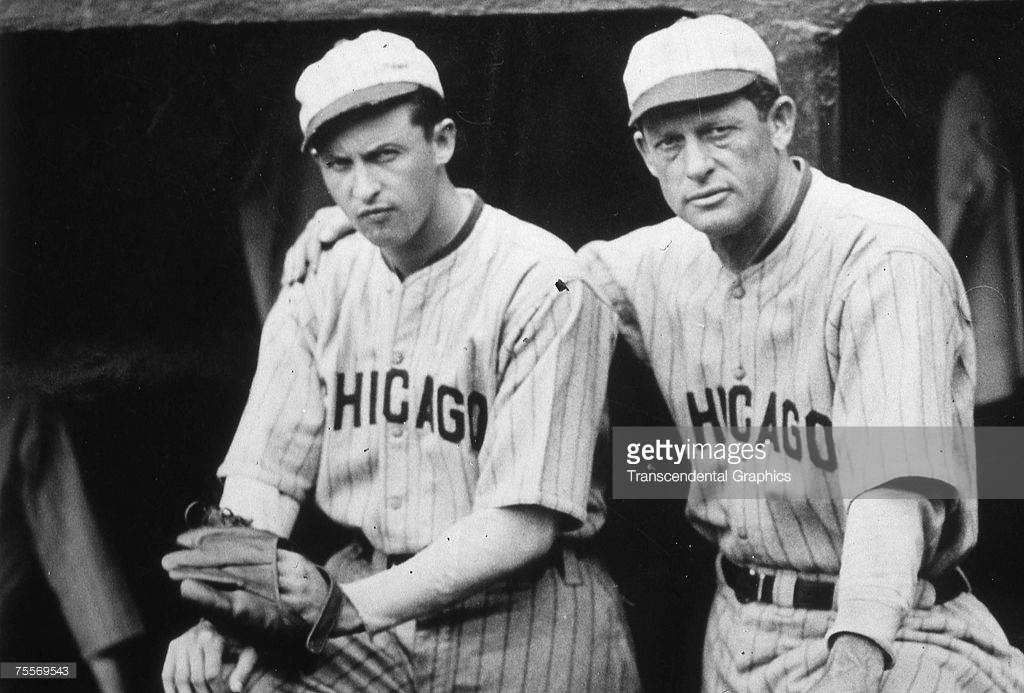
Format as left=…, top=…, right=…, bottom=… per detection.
left=840, top=3, right=1024, bottom=659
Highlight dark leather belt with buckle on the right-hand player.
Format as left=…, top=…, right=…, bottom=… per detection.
left=722, top=556, right=969, bottom=611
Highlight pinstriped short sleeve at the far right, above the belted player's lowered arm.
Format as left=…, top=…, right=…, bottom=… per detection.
left=828, top=245, right=977, bottom=500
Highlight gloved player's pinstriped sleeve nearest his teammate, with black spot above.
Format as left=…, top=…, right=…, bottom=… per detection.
left=474, top=275, right=615, bottom=529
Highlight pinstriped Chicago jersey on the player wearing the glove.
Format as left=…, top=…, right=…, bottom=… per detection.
left=218, top=191, right=615, bottom=554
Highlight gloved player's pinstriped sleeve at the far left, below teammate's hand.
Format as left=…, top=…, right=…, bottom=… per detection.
left=217, top=285, right=325, bottom=502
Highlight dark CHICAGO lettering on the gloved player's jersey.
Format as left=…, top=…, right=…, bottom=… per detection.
left=331, top=369, right=487, bottom=450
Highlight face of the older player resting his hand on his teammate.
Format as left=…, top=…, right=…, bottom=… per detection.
left=634, top=96, right=794, bottom=240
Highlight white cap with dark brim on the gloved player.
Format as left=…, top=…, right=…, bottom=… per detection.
left=295, top=31, right=444, bottom=150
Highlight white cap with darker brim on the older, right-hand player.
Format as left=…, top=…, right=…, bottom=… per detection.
left=623, top=14, right=778, bottom=125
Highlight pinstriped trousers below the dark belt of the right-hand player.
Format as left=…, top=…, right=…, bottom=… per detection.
left=703, top=575, right=1024, bottom=693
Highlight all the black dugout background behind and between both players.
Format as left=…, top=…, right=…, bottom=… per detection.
left=0, top=3, right=1024, bottom=690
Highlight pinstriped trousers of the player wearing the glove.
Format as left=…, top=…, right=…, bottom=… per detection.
left=247, top=551, right=640, bottom=693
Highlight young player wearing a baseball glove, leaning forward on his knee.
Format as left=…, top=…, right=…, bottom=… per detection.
left=163, top=31, right=638, bottom=691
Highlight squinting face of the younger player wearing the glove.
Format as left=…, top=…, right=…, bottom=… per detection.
left=315, top=103, right=455, bottom=254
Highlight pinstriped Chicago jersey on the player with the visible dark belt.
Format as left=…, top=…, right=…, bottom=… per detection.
left=581, top=160, right=977, bottom=574
